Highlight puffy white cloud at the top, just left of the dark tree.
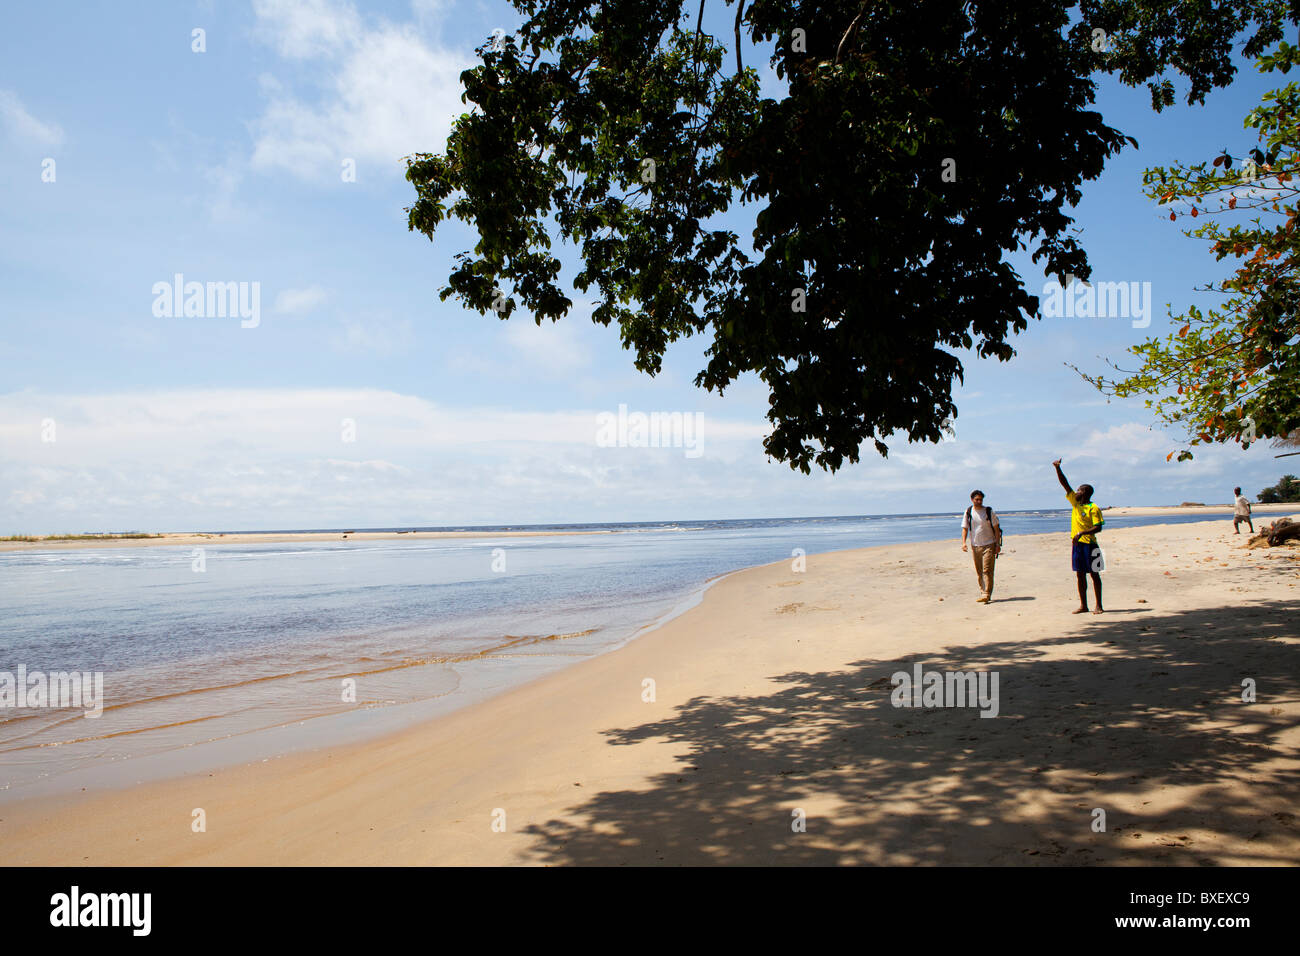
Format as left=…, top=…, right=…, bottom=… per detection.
left=251, top=0, right=473, bottom=179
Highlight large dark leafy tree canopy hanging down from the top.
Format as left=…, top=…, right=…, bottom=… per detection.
left=407, top=0, right=1300, bottom=472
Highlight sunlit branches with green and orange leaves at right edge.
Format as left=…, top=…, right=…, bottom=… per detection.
left=1084, top=43, right=1300, bottom=460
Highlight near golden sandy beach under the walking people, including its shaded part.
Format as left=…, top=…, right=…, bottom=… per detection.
left=0, top=515, right=1300, bottom=865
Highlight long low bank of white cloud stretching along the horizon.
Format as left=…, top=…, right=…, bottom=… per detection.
left=0, top=389, right=1282, bottom=533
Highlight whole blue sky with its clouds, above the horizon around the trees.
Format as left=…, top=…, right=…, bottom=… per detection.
left=0, top=0, right=1287, bottom=533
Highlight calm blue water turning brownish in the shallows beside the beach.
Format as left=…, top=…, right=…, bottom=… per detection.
left=0, top=510, right=1205, bottom=797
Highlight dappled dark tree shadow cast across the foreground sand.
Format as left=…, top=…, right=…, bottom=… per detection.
left=527, top=601, right=1300, bottom=865
